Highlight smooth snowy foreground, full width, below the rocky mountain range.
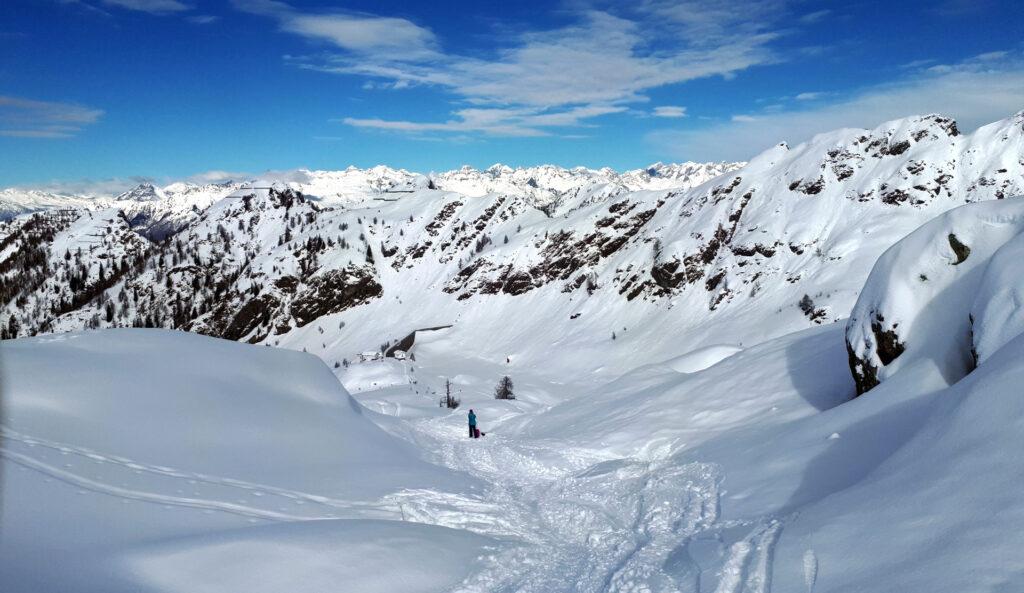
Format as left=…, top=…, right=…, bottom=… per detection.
left=6, top=198, right=1024, bottom=593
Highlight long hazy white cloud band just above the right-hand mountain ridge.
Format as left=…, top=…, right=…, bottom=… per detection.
left=648, top=51, right=1024, bottom=160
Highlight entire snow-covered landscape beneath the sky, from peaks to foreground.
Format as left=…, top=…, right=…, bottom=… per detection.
left=0, top=112, right=1024, bottom=593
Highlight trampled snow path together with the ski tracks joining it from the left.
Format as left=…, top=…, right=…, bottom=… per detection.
left=0, top=418, right=782, bottom=593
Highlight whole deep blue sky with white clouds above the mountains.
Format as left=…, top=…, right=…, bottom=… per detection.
left=0, top=0, right=1024, bottom=190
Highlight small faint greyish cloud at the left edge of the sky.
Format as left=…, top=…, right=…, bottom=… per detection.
left=0, top=95, right=103, bottom=138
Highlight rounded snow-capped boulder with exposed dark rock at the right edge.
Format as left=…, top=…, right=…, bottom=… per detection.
left=846, top=198, right=1024, bottom=393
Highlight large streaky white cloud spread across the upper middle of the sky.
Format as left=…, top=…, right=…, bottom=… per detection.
left=233, top=0, right=778, bottom=136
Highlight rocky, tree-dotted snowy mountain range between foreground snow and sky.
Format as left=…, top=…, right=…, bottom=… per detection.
left=0, top=113, right=1024, bottom=373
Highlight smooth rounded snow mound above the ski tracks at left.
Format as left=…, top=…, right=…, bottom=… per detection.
left=3, top=330, right=456, bottom=498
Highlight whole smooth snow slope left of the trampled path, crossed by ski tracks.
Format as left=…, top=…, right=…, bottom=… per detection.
left=0, top=330, right=486, bottom=593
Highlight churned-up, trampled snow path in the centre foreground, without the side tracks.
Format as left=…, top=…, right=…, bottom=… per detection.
left=391, top=418, right=781, bottom=593
